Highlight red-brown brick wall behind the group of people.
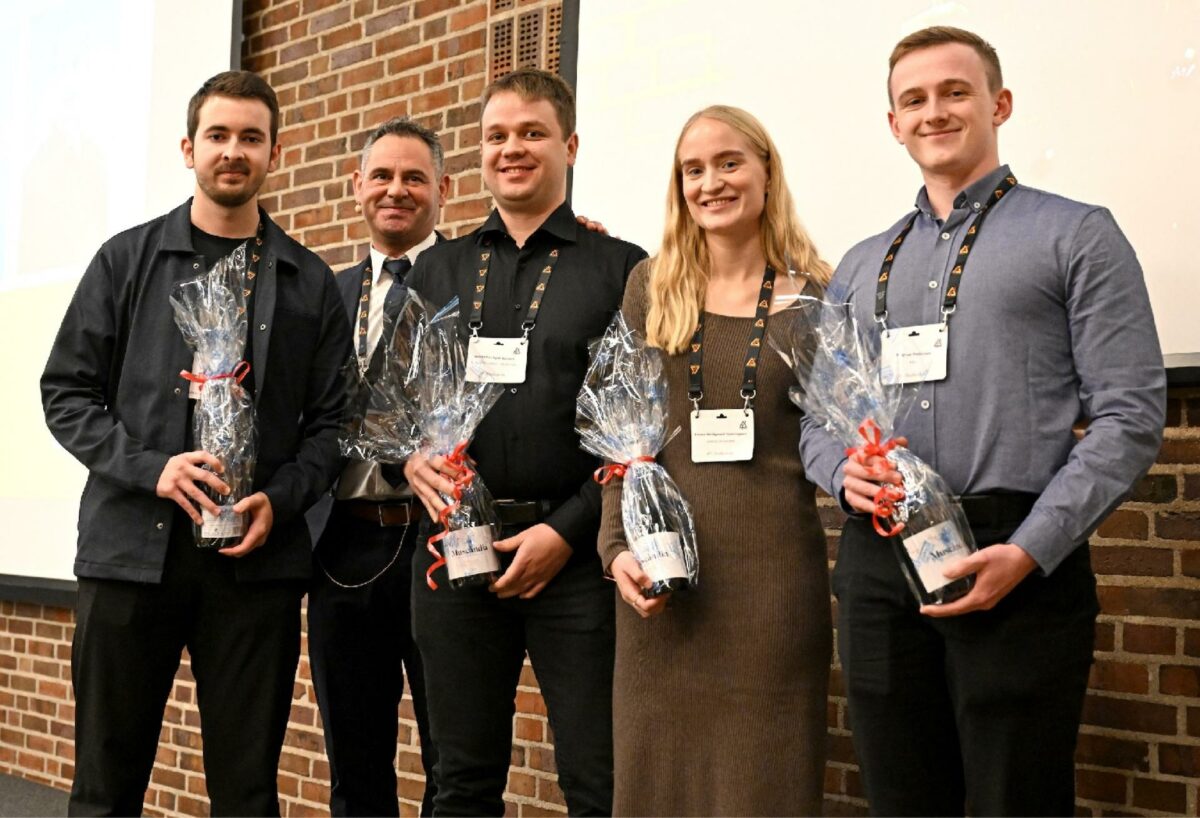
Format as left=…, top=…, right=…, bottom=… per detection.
left=0, top=0, right=1200, bottom=816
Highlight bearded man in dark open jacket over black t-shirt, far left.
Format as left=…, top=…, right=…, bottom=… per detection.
left=42, top=71, right=350, bottom=816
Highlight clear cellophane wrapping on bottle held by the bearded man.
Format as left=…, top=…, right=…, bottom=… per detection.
left=170, top=245, right=258, bottom=548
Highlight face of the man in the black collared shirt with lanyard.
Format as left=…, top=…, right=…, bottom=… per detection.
left=481, top=91, right=578, bottom=215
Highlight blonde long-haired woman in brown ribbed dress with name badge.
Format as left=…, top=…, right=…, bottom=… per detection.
left=599, top=106, right=830, bottom=816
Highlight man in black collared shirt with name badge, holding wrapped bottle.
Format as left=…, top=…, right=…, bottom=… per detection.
left=404, top=70, right=646, bottom=816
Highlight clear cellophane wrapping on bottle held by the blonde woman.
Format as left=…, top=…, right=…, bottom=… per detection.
left=575, top=312, right=700, bottom=584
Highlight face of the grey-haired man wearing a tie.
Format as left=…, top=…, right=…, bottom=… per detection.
left=354, top=134, right=450, bottom=257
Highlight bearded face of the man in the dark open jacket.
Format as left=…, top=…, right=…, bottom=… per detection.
left=182, top=95, right=280, bottom=209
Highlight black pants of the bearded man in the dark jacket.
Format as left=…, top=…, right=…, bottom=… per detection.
left=68, top=512, right=304, bottom=816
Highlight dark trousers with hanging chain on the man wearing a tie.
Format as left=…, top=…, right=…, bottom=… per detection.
left=308, top=503, right=437, bottom=816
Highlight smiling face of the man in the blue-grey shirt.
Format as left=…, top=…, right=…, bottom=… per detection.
left=888, top=43, right=1013, bottom=184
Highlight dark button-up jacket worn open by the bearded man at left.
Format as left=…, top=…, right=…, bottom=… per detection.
left=42, top=200, right=352, bottom=582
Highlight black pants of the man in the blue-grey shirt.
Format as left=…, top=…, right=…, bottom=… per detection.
left=833, top=518, right=1099, bottom=816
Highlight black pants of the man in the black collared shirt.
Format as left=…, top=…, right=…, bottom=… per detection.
left=413, top=529, right=616, bottom=816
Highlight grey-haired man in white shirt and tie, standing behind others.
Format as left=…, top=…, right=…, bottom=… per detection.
left=308, top=119, right=450, bottom=816
